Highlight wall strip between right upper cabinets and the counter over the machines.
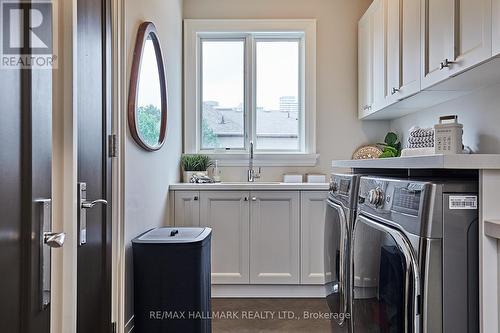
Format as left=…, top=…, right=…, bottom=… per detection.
left=391, top=85, right=500, bottom=154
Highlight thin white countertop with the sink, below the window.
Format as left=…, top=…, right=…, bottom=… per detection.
left=170, top=182, right=329, bottom=191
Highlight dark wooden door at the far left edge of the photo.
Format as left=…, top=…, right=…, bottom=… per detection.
left=0, top=5, right=52, bottom=333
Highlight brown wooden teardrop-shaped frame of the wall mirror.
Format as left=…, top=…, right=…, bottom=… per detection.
left=127, top=22, right=167, bottom=151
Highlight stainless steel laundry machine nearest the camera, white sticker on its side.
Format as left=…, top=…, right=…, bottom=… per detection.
left=351, top=177, right=479, bottom=333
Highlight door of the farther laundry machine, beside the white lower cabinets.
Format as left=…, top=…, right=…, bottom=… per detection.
left=324, top=200, right=350, bottom=325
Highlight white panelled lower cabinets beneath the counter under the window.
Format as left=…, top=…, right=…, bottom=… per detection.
left=173, top=190, right=327, bottom=285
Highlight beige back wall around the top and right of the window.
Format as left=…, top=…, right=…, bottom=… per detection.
left=184, top=0, right=389, bottom=181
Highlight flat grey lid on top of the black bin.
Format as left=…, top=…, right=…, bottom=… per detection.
left=132, top=227, right=212, bottom=244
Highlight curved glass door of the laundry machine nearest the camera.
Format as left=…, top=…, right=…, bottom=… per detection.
left=352, top=215, right=420, bottom=333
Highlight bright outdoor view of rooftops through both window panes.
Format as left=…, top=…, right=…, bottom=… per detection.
left=201, top=39, right=300, bottom=150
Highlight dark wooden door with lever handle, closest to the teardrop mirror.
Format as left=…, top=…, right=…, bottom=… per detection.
left=77, top=0, right=111, bottom=333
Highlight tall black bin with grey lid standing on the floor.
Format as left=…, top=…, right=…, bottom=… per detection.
left=132, top=227, right=212, bottom=333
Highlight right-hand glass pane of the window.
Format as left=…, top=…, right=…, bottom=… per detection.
left=256, top=40, right=301, bottom=150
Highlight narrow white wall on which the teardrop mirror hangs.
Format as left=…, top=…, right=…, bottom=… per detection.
left=122, top=0, right=182, bottom=321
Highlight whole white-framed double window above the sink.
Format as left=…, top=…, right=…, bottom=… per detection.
left=184, top=20, right=317, bottom=165
